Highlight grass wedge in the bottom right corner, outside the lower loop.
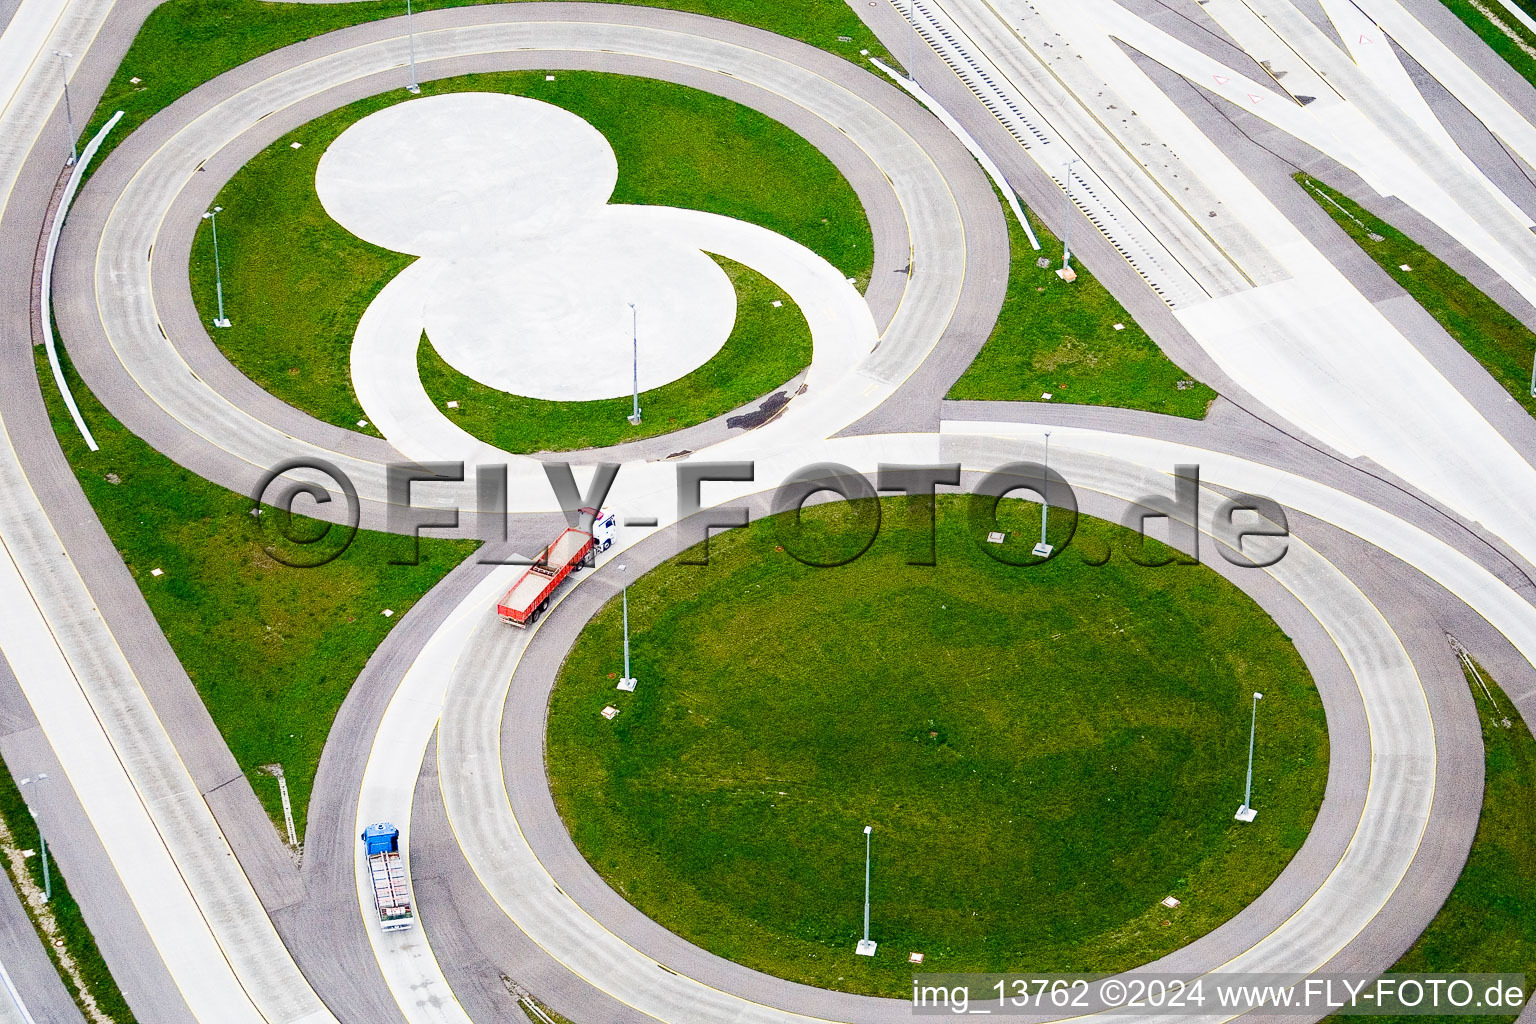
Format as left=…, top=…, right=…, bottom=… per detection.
left=1330, top=666, right=1536, bottom=1024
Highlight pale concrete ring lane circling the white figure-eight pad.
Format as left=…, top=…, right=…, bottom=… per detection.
left=55, top=3, right=1006, bottom=525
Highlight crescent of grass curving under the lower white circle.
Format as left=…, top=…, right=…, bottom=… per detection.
left=418, top=256, right=811, bottom=454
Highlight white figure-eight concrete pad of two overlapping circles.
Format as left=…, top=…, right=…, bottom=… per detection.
left=315, top=92, right=736, bottom=401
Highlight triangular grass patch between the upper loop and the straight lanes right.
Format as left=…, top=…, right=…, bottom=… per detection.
left=948, top=202, right=1217, bottom=419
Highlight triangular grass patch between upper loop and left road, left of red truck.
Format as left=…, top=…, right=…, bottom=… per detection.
left=37, top=348, right=476, bottom=837
